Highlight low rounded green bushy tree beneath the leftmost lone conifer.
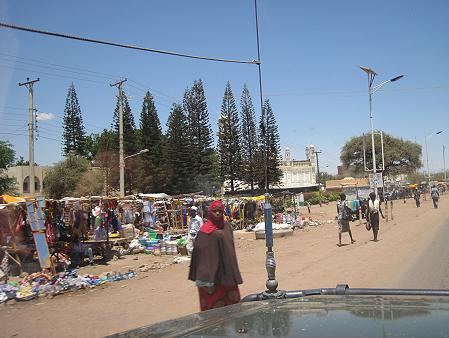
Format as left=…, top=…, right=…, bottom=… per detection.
left=44, top=154, right=90, bottom=199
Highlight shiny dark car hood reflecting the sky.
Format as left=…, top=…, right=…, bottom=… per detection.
left=107, top=296, right=449, bottom=337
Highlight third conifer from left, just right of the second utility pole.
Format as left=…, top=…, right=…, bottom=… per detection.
left=138, top=92, right=166, bottom=192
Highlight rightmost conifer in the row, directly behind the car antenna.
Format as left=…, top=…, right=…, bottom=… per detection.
left=256, top=99, right=282, bottom=190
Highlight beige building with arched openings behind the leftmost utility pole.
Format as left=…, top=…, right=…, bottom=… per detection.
left=7, top=165, right=49, bottom=196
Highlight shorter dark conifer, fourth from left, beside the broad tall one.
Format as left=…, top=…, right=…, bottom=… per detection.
left=166, top=104, right=194, bottom=194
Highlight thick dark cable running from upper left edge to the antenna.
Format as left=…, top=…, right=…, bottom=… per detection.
left=0, top=22, right=260, bottom=64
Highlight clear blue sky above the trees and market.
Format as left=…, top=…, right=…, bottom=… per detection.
left=0, top=0, right=449, bottom=173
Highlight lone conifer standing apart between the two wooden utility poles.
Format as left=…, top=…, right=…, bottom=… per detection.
left=62, top=83, right=86, bottom=156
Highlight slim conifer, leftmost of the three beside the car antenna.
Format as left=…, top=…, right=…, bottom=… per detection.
left=218, top=81, right=242, bottom=193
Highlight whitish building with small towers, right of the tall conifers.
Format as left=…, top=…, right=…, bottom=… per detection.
left=279, top=146, right=316, bottom=189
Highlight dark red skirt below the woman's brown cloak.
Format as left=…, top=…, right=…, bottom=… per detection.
left=198, top=285, right=240, bottom=311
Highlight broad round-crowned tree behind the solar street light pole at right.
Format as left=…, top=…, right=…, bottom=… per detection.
left=340, top=133, right=422, bottom=176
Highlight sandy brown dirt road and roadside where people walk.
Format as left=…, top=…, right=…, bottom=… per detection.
left=0, top=195, right=449, bottom=337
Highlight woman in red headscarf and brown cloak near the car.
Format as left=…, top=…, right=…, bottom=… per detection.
left=189, top=200, right=242, bottom=311
